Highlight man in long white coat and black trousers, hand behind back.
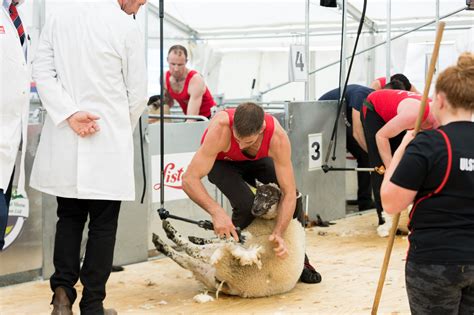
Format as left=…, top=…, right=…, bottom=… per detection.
left=31, top=0, right=148, bottom=315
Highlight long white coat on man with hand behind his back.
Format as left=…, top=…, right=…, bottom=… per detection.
left=30, top=0, right=147, bottom=200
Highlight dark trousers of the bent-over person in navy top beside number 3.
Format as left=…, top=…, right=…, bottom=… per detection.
left=346, top=126, right=372, bottom=208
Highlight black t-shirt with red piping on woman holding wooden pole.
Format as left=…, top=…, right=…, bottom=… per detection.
left=390, top=121, right=474, bottom=264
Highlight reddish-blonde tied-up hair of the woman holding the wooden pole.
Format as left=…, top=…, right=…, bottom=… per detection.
left=435, top=52, right=474, bottom=110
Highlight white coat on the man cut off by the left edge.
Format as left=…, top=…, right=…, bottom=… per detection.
left=0, top=0, right=31, bottom=195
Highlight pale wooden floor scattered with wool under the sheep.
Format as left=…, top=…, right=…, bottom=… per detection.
left=0, top=212, right=409, bottom=315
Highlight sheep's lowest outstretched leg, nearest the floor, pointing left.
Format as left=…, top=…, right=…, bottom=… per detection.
left=152, top=233, right=219, bottom=290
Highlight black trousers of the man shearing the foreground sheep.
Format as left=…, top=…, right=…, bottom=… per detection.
left=208, top=157, right=304, bottom=229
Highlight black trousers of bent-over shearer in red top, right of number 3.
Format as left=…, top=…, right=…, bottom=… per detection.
left=360, top=105, right=406, bottom=223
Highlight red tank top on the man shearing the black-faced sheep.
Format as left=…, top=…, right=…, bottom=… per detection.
left=201, top=109, right=275, bottom=161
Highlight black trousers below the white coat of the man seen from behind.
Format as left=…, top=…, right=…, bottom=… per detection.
left=50, top=197, right=121, bottom=315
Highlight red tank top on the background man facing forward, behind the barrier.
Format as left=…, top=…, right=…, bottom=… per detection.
left=166, top=70, right=216, bottom=117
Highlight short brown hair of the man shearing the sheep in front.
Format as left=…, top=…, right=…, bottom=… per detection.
left=233, top=102, right=265, bottom=137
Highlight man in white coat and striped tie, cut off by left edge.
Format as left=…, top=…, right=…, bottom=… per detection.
left=0, top=0, right=31, bottom=251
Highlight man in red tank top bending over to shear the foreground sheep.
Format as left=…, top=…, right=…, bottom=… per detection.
left=183, top=103, right=321, bottom=283
